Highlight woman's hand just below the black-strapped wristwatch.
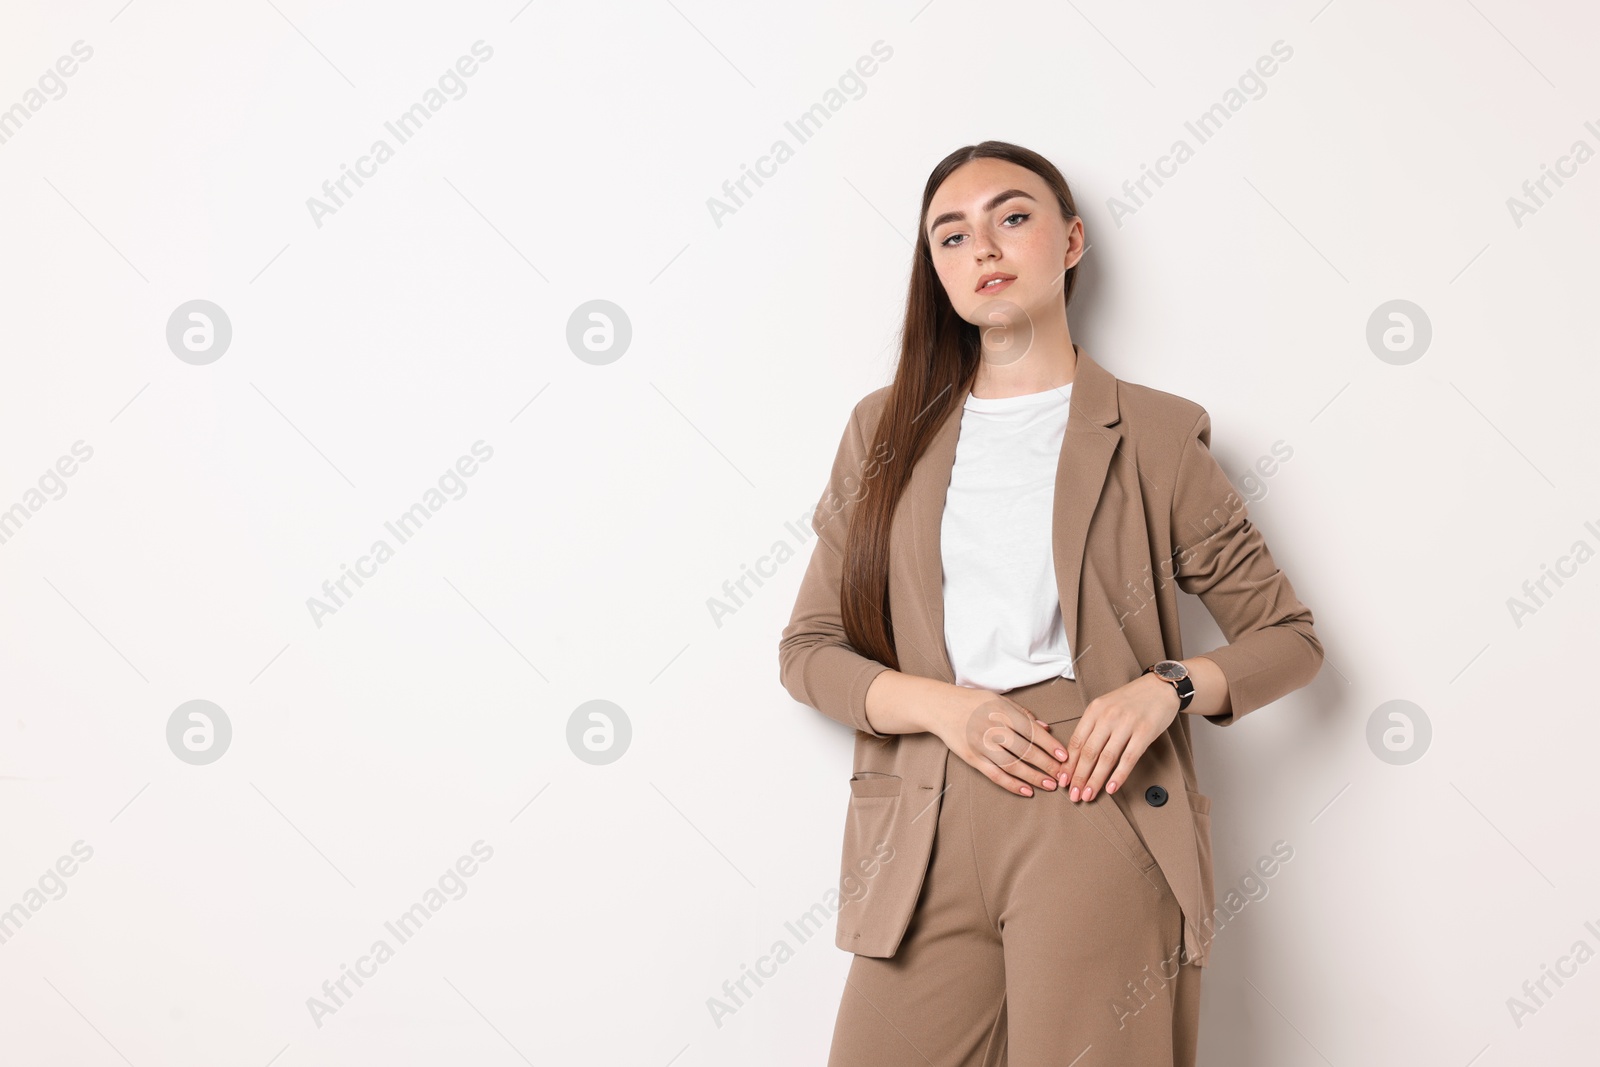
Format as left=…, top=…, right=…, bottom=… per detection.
left=1058, top=673, right=1179, bottom=800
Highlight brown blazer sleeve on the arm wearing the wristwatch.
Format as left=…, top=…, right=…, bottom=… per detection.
left=1171, top=410, right=1323, bottom=726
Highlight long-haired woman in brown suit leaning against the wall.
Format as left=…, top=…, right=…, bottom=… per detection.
left=779, top=141, right=1322, bottom=1067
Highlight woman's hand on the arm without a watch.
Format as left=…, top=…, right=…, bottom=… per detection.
left=930, top=683, right=1068, bottom=797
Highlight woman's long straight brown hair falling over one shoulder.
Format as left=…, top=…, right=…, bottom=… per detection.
left=840, top=141, right=1078, bottom=670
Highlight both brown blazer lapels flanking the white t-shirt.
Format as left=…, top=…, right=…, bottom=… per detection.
left=915, top=346, right=1122, bottom=685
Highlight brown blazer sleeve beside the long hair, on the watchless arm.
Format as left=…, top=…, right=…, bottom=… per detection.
left=778, top=405, right=888, bottom=737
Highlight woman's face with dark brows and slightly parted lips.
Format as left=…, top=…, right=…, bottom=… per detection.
left=923, top=158, right=1083, bottom=326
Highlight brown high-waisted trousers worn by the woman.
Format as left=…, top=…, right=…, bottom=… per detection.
left=827, top=678, right=1200, bottom=1067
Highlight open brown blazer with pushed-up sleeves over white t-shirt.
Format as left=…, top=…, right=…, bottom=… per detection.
left=779, top=346, right=1323, bottom=965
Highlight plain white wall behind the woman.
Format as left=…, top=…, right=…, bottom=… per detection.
left=0, top=0, right=1600, bottom=1067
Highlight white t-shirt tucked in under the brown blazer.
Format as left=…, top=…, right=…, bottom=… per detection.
left=939, top=384, right=1075, bottom=693
